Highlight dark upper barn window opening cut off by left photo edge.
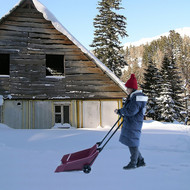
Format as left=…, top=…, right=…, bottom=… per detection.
left=0, top=54, right=10, bottom=75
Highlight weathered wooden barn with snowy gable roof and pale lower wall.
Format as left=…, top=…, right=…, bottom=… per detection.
left=0, top=0, right=126, bottom=129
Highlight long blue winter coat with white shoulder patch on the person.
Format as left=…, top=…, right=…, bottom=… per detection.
left=118, top=90, right=148, bottom=147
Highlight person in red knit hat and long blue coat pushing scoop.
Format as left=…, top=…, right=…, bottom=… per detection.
left=115, top=74, right=148, bottom=169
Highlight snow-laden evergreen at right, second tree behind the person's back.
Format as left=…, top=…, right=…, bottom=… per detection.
left=160, top=53, right=183, bottom=122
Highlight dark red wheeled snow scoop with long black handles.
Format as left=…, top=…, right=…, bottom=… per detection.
left=55, top=116, right=123, bottom=173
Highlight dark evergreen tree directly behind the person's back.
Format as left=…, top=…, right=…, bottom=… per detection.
left=141, top=60, right=160, bottom=120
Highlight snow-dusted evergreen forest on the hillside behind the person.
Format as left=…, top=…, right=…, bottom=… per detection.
left=120, top=30, right=190, bottom=123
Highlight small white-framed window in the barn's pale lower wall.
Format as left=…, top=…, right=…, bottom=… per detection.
left=55, top=105, right=70, bottom=124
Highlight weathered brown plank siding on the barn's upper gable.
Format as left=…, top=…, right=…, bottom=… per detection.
left=0, top=0, right=126, bottom=99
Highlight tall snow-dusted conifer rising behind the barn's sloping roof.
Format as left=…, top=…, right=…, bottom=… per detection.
left=91, top=0, right=127, bottom=77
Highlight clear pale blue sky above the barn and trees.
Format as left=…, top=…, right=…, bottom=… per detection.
left=0, top=0, right=190, bottom=50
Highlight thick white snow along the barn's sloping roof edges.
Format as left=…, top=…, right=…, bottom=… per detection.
left=0, top=0, right=126, bottom=92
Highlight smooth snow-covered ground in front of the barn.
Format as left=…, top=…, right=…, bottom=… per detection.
left=0, top=121, right=190, bottom=190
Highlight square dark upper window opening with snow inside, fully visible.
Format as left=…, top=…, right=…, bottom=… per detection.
left=46, top=55, right=65, bottom=76
